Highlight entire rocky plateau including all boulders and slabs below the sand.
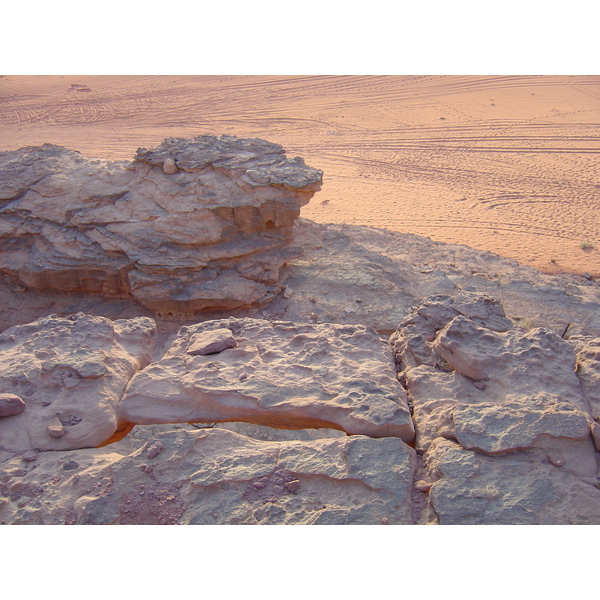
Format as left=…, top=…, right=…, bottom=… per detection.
left=0, top=136, right=600, bottom=525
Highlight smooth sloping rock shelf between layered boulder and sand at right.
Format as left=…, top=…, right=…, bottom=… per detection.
left=265, top=218, right=600, bottom=337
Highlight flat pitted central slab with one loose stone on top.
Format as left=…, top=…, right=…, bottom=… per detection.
left=119, top=318, right=414, bottom=442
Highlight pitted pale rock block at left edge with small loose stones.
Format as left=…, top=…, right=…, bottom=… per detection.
left=0, top=313, right=156, bottom=452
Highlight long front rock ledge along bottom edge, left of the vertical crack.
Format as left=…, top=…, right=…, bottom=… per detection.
left=0, top=429, right=416, bottom=525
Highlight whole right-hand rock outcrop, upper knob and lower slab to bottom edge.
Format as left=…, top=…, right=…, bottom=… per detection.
left=391, top=293, right=600, bottom=524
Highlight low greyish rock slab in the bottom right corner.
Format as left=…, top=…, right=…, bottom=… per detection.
left=426, top=438, right=600, bottom=525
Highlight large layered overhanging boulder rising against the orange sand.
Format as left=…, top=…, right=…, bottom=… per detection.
left=0, top=136, right=322, bottom=317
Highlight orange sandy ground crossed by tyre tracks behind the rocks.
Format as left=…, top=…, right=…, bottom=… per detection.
left=0, top=76, right=600, bottom=276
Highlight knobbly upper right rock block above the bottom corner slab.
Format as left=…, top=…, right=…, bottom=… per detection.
left=391, top=294, right=597, bottom=481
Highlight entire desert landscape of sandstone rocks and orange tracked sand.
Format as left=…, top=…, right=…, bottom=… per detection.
left=0, top=75, right=600, bottom=525
